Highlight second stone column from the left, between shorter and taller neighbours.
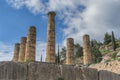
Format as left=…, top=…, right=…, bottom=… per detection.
left=18, top=37, right=27, bottom=62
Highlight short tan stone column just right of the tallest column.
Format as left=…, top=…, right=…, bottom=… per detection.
left=66, top=38, right=75, bottom=65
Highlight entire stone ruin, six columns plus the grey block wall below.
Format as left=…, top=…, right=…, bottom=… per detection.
left=0, top=11, right=120, bottom=80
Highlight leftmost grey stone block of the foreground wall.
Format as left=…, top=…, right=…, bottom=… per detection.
left=0, top=62, right=27, bottom=80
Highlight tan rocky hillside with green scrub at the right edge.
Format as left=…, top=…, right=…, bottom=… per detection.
left=89, top=41, right=120, bottom=74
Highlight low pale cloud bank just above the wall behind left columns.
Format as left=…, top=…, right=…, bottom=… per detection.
left=0, top=41, right=46, bottom=61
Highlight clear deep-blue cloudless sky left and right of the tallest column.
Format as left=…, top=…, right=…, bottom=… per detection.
left=0, top=0, right=62, bottom=44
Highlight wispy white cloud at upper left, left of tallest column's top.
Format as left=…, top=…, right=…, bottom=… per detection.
left=6, top=0, right=46, bottom=14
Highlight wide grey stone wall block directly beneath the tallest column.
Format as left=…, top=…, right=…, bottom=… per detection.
left=28, top=62, right=60, bottom=80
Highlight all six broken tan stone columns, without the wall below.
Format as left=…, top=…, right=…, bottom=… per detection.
left=13, top=11, right=92, bottom=65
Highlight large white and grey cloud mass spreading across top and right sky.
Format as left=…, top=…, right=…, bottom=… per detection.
left=7, top=0, right=120, bottom=50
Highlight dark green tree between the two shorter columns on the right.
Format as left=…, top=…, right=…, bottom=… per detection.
left=74, top=44, right=83, bottom=58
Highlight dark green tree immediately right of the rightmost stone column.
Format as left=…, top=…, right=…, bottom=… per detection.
left=91, top=40, right=102, bottom=63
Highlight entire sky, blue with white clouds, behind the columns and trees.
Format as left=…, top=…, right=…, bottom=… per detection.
left=0, top=0, right=120, bottom=61
